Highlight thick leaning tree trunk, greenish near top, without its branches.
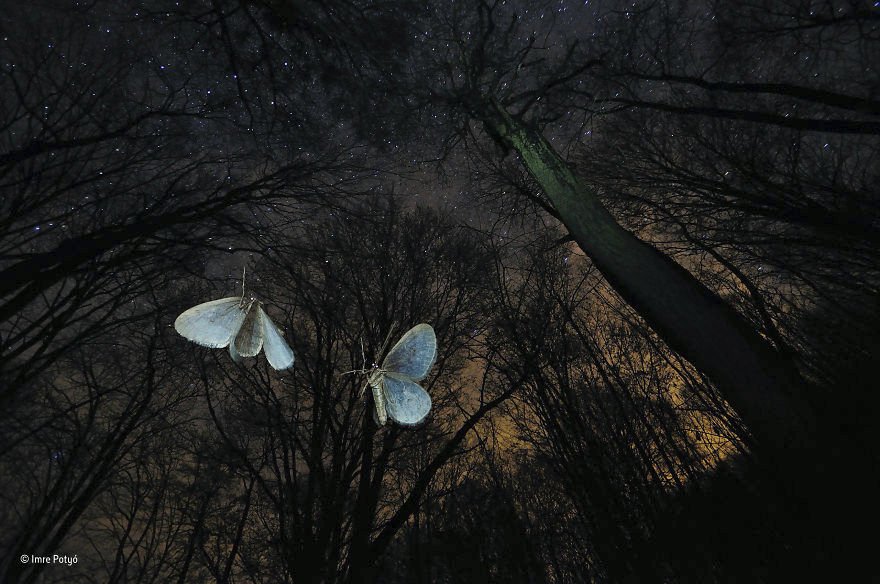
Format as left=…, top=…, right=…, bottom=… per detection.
left=476, top=102, right=816, bottom=462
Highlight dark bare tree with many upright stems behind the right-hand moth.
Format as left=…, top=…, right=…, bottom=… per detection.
left=146, top=198, right=515, bottom=582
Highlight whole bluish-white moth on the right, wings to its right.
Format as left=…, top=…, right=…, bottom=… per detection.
left=367, top=323, right=437, bottom=426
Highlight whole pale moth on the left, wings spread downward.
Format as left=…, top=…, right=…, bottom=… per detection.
left=174, top=278, right=293, bottom=371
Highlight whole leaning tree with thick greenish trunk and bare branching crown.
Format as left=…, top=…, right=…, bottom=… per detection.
left=253, top=2, right=818, bottom=460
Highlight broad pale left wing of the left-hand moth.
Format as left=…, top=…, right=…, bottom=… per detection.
left=174, top=297, right=246, bottom=349
